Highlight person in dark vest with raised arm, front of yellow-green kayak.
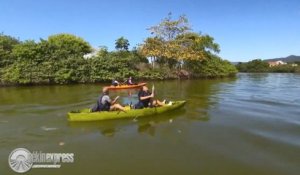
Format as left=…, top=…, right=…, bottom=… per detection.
left=134, top=86, right=165, bottom=109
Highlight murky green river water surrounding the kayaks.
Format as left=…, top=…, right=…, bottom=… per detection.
left=0, top=74, right=300, bottom=175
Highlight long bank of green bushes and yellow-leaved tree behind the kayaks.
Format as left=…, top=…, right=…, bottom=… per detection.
left=0, top=14, right=237, bottom=85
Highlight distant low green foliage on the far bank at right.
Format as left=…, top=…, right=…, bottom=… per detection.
left=236, top=59, right=300, bottom=73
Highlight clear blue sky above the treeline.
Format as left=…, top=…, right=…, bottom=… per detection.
left=0, top=0, right=300, bottom=61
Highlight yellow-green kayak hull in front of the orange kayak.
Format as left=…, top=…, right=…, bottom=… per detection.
left=68, top=101, right=186, bottom=122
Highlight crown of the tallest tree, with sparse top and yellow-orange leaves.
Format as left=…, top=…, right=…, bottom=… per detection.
left=139, top=14, right=220, bottom=68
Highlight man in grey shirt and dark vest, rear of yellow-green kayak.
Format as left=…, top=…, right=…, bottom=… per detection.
left=92, top=87, right=125, bottom=112
